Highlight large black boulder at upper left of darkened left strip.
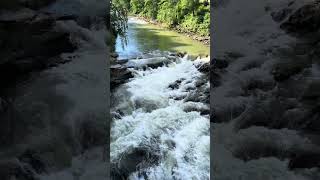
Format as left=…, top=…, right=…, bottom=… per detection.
left=0, top=10, right=76, bottom=84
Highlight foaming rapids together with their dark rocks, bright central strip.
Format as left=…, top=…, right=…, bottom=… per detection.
left=110, top=52, right=210, bottom=180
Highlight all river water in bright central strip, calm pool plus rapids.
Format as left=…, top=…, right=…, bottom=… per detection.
left=111, top=17, right=210, bottom=180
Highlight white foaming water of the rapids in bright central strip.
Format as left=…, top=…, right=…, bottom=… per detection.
left=110, top=57, right=210, bottom=180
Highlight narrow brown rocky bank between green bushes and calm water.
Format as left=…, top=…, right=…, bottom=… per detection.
left=131, top=15, right=210, bottom=46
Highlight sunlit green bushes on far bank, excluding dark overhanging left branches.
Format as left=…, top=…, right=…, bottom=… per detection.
left=130, top=0, right=210, bottom=36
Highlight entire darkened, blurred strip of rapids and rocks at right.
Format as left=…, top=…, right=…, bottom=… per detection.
left=211, top=0, right=320, bottom=180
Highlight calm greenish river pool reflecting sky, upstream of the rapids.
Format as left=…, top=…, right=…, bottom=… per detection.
left=116, top=18, right=210, bottom=59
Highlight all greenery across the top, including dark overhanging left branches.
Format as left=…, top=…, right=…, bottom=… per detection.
left=111, top=0, right=210, bottom=36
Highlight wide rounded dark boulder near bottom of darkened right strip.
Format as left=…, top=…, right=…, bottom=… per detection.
left=231, top=126, right=319, bottom=161
